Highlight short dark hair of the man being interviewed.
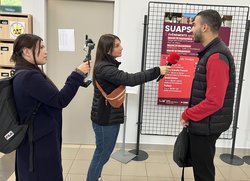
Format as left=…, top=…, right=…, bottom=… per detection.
left=196, top=9, right=222, bottom=33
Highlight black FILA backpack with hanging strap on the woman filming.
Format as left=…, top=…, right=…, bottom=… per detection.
left=0, top=70, right=41, bottom=171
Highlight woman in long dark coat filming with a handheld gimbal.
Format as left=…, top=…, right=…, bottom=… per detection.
left=11, top=34, right=90, bottom=181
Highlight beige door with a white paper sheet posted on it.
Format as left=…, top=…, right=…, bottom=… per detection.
left=47, top=0, right=114, bottom=144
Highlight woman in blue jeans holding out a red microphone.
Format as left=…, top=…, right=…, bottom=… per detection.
left=87, top=34, right=170, bottom=181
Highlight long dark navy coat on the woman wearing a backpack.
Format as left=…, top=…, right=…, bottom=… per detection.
left=13, top=70, right=83, bottom=181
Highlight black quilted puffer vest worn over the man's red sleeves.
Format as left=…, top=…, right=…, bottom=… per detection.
left=189, top=38, right=235, bottom=135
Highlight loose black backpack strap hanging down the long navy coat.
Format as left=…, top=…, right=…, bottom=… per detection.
left=27, top=102, right=41, bottom=172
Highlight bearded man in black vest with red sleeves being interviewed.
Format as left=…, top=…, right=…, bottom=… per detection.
left=181, top=10, right=235, bottom=181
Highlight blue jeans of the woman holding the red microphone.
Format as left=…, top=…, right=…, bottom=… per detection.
left=87, top=122, right=120, bottom=181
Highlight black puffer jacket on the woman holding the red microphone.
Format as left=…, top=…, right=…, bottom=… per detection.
left=91, top=58, right=160, bottom=126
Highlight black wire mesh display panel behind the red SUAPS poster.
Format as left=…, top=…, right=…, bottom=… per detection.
left=140, top=2, right=249, bottom=139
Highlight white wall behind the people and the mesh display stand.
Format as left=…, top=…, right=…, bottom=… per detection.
left=20, top=0, right=250, bottom=148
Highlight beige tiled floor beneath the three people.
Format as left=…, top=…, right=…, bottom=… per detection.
left=0, top=145, right=250, bottom=181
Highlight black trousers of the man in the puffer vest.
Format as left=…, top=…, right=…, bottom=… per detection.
left=189, top=133, right=220, bottom=181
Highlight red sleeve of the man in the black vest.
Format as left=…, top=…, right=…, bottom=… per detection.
left=182, top=53, right=229, bottom=121
